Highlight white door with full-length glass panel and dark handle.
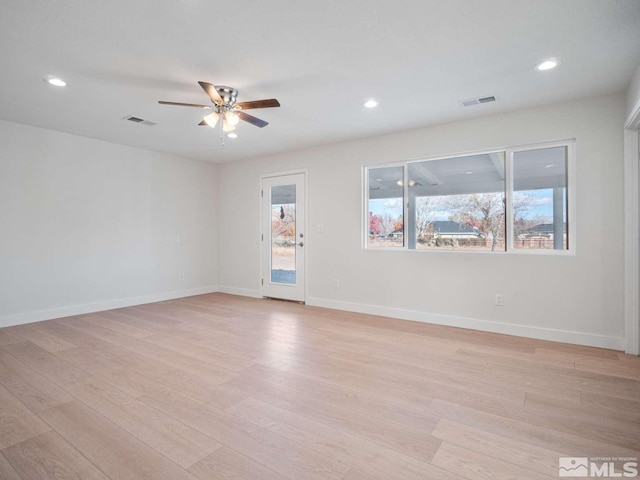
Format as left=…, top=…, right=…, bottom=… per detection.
left=261, top=173, right=306, bottom=302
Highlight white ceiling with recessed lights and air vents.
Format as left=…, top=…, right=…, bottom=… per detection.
left=0, top=0, right=640, bottom=162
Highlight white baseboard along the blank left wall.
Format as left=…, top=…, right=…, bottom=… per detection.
left=0, top=285, right=219, bottom=327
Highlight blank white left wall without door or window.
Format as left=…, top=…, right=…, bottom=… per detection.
left=0, top=121, right=217, bottom=326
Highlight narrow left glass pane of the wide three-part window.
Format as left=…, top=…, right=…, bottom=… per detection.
left=367, top=166, right=404, bottom=247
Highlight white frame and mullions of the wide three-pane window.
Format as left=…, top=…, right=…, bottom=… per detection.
left=360, top=139, right=577, bottom=256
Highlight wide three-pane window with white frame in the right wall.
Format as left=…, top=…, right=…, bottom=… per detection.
left=365, top=142, right=572, bottom=252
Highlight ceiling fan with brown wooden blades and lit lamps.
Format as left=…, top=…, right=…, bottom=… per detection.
left=158, top=82, right=280, bottom=138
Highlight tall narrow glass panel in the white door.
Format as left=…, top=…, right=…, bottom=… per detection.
left=271, top=185, right=296, bottom=285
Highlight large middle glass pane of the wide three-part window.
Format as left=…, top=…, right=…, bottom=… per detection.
left=407, top=152, right=506, bottom=251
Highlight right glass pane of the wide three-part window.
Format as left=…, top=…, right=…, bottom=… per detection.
left=512, top=146, right=568, bottom=250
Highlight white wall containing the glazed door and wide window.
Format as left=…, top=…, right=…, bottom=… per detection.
left=219, top=95, right=625, bottom=349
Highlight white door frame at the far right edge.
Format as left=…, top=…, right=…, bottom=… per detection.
left=624, top=102, right=640, bottom=355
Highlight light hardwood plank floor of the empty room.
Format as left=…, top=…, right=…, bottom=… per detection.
left=0, top=294, right=640, bottom=480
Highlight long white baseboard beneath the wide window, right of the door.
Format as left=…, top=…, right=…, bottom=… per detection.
left=307, top=298, right=625, bottom=350
